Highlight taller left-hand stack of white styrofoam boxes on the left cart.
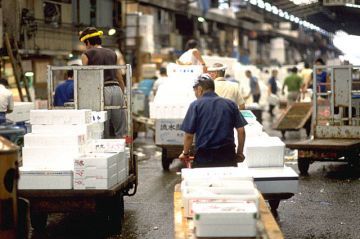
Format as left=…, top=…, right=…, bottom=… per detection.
left=19, top=110, right=91, bottom=189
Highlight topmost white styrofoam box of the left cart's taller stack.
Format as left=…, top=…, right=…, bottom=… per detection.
left=30, top=110, right=91, bottom=125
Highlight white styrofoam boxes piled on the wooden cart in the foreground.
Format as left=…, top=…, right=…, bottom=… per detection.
left=181, top=167, right=259, bottom=237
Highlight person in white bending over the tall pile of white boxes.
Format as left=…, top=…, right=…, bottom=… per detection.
left=176, top=39, right=207, bottom=72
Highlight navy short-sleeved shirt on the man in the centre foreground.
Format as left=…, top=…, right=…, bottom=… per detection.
left=181, top=92, right=247, bottom=150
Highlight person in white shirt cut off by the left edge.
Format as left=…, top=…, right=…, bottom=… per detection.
left=0, top=78, right=14, bottom=124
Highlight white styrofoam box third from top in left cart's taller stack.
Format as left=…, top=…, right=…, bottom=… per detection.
left=24, top=133, right=85, bottom=147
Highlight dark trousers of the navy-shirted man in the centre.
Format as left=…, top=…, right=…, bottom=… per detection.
left=192, top=145, right=237, bottom=168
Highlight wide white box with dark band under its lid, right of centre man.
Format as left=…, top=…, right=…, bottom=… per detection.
left=249, top=166, right=299, bottom=193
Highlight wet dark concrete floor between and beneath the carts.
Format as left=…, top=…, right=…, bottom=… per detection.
left=31, top=112, right=360, bottom=239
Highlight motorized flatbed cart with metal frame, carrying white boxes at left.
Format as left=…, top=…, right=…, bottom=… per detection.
left=19, top=65, right=138, bottom=232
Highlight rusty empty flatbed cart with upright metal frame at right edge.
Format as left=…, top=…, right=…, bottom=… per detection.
left=286, top=65, right=360, bottom=175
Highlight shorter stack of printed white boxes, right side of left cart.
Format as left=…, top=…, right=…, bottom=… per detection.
left=74, top=139, right=129, bottom=189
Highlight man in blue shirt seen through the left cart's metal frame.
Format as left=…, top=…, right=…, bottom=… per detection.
left=54, top=70, right=74, bottom=106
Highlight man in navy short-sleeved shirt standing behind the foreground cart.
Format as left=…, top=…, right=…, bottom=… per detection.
left=179, top=74, right=247, bottom=167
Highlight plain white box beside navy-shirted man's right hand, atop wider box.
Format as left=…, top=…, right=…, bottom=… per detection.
left=244, top=137, right=285, bottom=168
